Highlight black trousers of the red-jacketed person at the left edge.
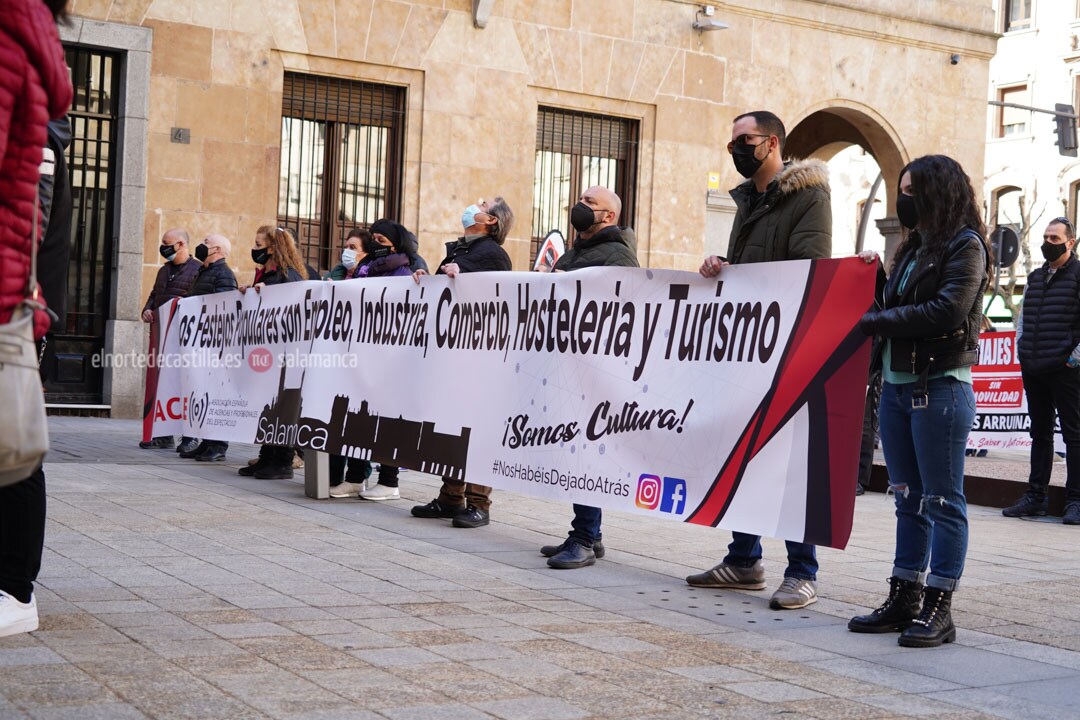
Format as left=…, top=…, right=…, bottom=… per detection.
left=0, top=466, right=45, bottom=602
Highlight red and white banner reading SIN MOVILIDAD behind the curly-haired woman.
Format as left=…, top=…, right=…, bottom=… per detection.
left=968, top=330, right=1065, bottom=452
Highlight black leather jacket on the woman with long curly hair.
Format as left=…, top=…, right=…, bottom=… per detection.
left=859, top=230, right=990, bottom=375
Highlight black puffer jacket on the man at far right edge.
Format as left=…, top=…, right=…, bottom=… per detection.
left=1018, top=255, right=1080, bottom=372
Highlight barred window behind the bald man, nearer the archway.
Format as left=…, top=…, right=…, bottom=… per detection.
left=530, top=107, right=639, bottom=259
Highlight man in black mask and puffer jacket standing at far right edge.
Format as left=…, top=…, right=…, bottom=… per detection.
left=1001, top=217, right=1080, bottom=525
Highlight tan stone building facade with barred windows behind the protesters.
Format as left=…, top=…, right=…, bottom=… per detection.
left=54, top=0, right=996, bottom=417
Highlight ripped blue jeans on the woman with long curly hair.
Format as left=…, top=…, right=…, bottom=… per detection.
left=879, top=377, right=975, bottom=590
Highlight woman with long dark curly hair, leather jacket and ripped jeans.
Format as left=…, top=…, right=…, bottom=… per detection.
left=848, top=155, right=990, bottom=648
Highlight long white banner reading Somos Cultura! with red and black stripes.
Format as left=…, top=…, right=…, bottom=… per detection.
left=153, top=258, right=875, bottom=547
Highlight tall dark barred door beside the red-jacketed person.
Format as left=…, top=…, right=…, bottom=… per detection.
left=44, top=47, right=121, bottom=404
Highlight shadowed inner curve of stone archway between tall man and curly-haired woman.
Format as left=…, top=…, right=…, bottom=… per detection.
left=785, top=101, right=907, bottom=262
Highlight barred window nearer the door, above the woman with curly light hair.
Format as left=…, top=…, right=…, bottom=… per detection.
left=278, top=72, right=405, bottom=270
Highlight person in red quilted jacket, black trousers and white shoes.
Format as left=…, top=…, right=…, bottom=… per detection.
left=0, top=0, right=72, bottom=637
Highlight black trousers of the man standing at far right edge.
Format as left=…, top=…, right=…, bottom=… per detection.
left=1022, top=367, right=1080, bottom=502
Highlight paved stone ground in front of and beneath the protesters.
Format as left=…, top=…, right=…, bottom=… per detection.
left=0, top=418, right=1080, bottom=720
